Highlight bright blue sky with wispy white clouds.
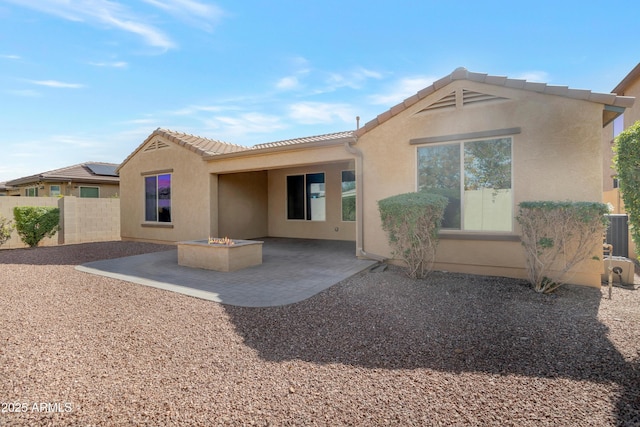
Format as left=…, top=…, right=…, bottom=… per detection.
left=0, top=0, right=640, bottom=181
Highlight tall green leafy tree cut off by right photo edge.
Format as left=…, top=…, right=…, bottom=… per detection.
left=613, top=121, right=640, bottom=256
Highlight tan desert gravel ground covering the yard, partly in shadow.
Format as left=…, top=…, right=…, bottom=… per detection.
left=0, top=242, right=640, bottom=426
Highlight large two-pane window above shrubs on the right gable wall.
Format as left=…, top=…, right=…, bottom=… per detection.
left=418, top=138, right=513, bottom=231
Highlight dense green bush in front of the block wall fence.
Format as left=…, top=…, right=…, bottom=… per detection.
left=13, top=206, right=60, bottom=248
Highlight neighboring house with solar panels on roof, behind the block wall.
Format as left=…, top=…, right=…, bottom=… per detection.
left=5, top=162, right=120, bottom=198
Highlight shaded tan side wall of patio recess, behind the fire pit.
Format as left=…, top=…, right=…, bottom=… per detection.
left=217, top=171, right=269, bottom=239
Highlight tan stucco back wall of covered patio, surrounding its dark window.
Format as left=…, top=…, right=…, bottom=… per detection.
left=269, top=161, right=356, bottom=241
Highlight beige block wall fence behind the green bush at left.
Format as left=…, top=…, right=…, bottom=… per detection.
left=0, top=196, right=120, bottom=250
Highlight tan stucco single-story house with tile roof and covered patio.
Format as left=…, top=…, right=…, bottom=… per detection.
left=118, top=68, right=634, bottom=286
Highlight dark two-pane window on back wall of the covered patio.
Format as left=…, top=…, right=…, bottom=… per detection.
left=287, top=173, right=326, bottom=221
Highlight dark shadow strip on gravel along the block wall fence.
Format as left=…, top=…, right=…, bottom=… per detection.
left=0, top=241, right=175, bottom=265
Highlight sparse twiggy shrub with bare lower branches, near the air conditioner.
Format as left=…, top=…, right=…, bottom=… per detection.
left=516, top=201, right=609, bottom=293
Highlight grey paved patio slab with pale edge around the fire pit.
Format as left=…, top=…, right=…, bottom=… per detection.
left=76, top=237, right=376, bottom=307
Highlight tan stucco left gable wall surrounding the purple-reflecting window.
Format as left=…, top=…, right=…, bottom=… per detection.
left=120, top=136, right=212, bottom=246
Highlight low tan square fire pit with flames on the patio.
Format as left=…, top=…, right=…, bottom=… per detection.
left=178, top=237, right=263, bottom=272
